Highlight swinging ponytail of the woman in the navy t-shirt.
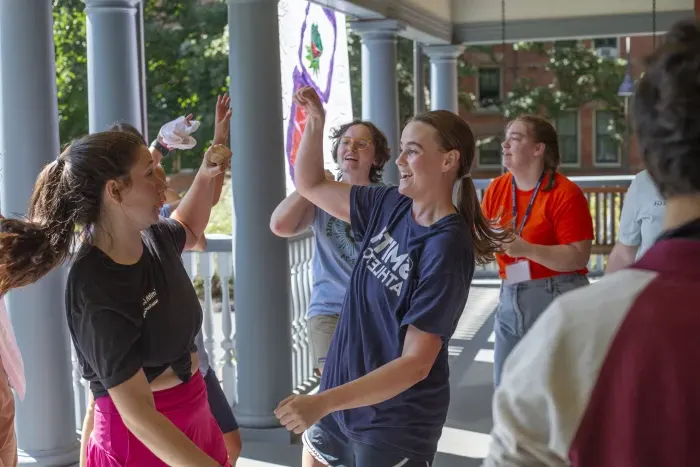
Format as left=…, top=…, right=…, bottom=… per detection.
left=457, top=175, right=512, bottom=266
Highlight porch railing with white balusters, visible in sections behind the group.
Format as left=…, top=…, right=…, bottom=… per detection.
left=71, top=176, right=632, bottom=430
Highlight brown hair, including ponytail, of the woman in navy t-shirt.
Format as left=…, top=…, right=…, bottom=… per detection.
left=411, top=110, right=511, bottom=265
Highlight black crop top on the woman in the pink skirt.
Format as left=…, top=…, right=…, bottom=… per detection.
left=66, top=219, right=202, bottom=398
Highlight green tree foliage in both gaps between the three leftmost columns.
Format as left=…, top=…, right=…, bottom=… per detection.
left=53, top=0, right=228, bottom=169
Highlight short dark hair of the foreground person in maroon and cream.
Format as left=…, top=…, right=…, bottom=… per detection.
left=633, top=20, right=700, bottom=197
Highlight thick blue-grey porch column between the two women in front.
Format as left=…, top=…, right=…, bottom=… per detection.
left=228, top=0, right=293, bottom=443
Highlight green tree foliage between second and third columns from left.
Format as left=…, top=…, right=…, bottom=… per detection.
left=144, top=0, right=228, bottom=170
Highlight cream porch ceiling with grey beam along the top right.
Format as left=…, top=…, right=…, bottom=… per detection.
left=312, top=0, right=695, bottom=44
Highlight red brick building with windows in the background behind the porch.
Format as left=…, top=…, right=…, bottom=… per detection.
left=460, top=36, right=659, bottom=178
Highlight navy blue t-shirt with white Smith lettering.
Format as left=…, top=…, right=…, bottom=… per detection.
left=319, top=186, right=475, bottom=461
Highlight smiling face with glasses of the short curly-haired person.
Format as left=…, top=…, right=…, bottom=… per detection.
left=336, top=124, right=375, bottom=182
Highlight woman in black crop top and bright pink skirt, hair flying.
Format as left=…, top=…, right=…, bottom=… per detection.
left=0, top=111, right=231, bottom=467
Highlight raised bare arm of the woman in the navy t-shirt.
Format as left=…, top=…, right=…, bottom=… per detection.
left=294, top=87, right=351, bottom=223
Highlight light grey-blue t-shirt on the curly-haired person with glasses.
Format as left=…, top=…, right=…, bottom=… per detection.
left=306, top=207, right=358, bottom=319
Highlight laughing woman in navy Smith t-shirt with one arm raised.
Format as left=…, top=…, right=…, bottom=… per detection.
left=275, top=88, right=507, bottom=467
